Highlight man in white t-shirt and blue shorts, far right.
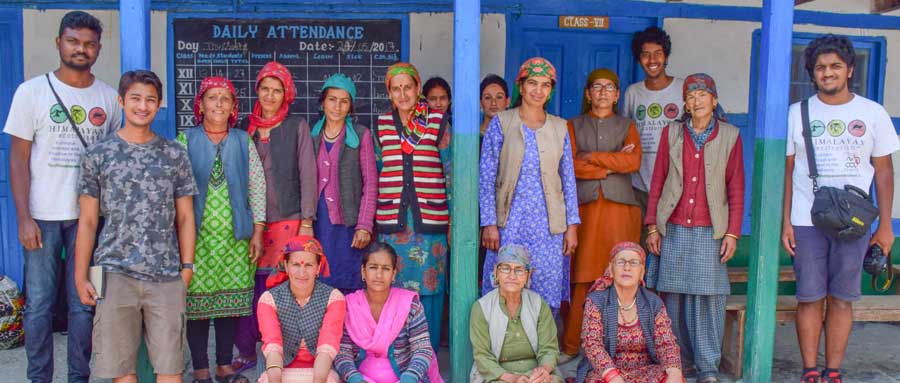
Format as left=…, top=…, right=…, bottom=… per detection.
left=781, top=34, right=900, bottom=383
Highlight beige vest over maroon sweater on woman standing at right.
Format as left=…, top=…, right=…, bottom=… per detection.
left=656, top=121, right=744, bottom=239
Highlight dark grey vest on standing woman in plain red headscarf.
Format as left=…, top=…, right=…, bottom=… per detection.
left=237, top=117, right=308, bottom=217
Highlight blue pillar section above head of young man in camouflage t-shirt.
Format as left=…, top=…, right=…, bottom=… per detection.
left=119, top=0, right=150, bottom=73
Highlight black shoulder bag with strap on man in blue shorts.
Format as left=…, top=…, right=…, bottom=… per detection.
left=800, top=100, right=878, bottom=241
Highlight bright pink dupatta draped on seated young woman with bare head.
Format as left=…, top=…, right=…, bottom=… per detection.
left=344, top=287, right=444, bottom=383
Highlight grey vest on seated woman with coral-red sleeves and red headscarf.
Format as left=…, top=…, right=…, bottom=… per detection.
left=269, top=281, right=334, bottom=366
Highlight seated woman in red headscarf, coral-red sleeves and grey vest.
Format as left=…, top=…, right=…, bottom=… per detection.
left=256, top=235, right=347, bottom=383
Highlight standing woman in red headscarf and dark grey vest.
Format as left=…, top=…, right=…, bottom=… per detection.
left=234, top=61, right=318, bottom=371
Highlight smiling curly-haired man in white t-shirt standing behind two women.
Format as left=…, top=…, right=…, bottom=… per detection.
left=620, top=27, right=684, bottom=288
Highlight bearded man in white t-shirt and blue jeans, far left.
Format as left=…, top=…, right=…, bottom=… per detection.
left=3, top=11, right=122, bottom=382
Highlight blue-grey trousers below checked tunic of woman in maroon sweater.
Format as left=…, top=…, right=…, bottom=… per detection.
left=664, top=293, right=727, bottom=381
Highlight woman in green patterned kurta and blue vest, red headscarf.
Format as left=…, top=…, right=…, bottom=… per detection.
left=176, top=77, right=266, bottom=383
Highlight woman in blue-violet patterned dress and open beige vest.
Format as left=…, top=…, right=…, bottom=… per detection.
left=479, top=57, right=581, bottom=316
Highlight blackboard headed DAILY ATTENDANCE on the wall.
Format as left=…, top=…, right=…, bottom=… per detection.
left=172, top=18, right=402, bottom=131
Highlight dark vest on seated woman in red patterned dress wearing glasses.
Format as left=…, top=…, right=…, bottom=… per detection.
left=575, top=285, right=663, bottom=383
